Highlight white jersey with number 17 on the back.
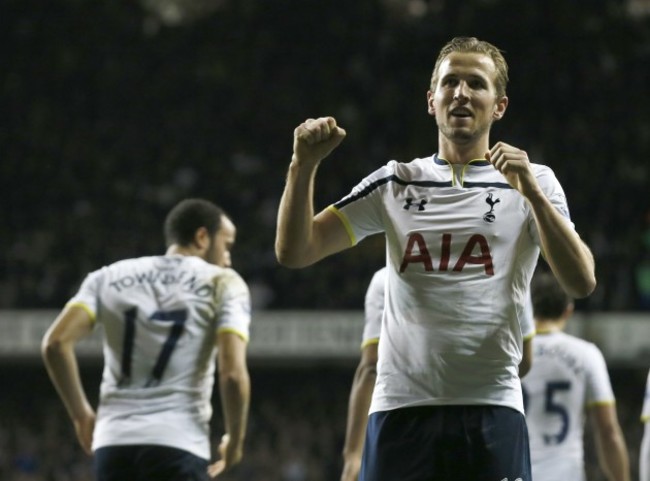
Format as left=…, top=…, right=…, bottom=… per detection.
left=68, top=251, right=251, bottom=459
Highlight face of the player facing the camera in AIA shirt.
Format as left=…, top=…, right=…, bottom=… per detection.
left=427, top=52, right=508, bottom=144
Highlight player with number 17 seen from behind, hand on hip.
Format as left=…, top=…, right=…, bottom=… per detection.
left=42, top=199, right=251, bottom=481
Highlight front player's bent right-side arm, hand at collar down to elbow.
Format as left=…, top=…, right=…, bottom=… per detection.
left=485, top=142, right=596, bottom=298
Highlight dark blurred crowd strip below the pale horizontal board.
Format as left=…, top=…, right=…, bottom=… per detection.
left=0, top=364, right=647, bottom=481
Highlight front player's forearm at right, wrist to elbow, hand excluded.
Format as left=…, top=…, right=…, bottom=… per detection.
left=529, top=191, right=596, bottom=298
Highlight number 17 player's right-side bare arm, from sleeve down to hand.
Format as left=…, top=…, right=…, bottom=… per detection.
left=208, top=332, right=250, bottom=477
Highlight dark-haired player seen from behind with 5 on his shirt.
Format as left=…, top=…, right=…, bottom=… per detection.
left=523, top=273, right=630, bottom=481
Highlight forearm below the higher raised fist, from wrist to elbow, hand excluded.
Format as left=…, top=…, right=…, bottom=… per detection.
left=275, top=159, right=316, bottom=267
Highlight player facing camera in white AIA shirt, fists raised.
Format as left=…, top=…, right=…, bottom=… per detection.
left=275, top=37, right=596, bottom=481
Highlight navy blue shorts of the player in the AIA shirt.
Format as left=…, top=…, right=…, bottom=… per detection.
left=359, top=406, right=531, bottom=481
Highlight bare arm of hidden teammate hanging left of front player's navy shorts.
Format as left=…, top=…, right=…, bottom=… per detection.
left=341, top=342, right=377, bottom=481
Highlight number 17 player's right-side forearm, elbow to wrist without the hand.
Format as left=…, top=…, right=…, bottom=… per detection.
left=219, top=370, right=250, bottom=448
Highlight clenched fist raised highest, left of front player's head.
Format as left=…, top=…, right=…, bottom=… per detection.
left=292, top=117, right=346, bottom=166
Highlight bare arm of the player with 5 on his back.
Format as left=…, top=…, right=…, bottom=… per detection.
left=589, top=404, right=630, bottom=481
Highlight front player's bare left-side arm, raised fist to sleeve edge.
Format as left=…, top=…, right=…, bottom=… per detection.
left=275, top=117, right=350, bottom=268
